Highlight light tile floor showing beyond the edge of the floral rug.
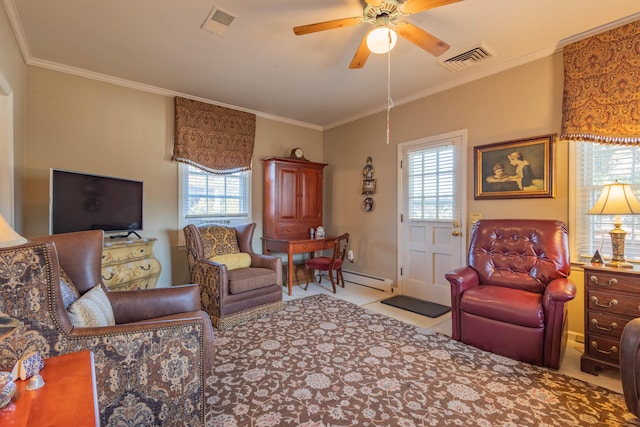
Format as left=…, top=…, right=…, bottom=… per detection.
left=283, top=279, right=622, bottom=393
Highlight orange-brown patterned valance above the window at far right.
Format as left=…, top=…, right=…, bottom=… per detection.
left=561, top=21, right=640, bottom=145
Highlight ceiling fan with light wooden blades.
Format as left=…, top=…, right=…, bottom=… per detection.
left=293, top=0, right=461, bottom=68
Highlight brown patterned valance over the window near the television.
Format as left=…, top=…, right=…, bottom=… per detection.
left=173, top=97, right=256, bottom=174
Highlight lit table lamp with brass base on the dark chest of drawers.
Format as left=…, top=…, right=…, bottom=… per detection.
left=587, top=180, right=640, bottom=268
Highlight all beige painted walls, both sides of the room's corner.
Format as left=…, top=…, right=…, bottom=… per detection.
left=5, top=1, right=583, bottom=338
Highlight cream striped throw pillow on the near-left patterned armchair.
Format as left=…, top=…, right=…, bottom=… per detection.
left=67, top=284, right=116, bottom=328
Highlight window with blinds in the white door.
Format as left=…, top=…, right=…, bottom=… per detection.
left=407, top=145, right=454, bottom=221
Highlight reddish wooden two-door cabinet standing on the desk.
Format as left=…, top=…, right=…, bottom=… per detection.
left=262, top=157, right=327, bottom=239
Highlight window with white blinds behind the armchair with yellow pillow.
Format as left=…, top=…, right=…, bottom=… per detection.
left=179, top=164, right=251, bottom=231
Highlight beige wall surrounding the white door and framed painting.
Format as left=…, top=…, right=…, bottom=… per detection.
left=323, top=53, right=583, bottom=332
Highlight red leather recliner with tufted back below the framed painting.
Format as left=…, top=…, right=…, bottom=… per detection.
left=446, top=219, right=576, bottom=369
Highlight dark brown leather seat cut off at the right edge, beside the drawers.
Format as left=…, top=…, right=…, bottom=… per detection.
left=620, top=318, right=640, bottom=418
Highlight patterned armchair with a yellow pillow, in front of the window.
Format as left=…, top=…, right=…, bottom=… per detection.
left=184, top=223, right=282, bottom=329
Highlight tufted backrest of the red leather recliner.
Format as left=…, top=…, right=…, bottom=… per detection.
left=469, top=220, right=571, bottom=293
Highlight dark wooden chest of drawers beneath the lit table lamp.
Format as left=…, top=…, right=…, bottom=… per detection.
left=580, top=265, right=640, bottom=375
